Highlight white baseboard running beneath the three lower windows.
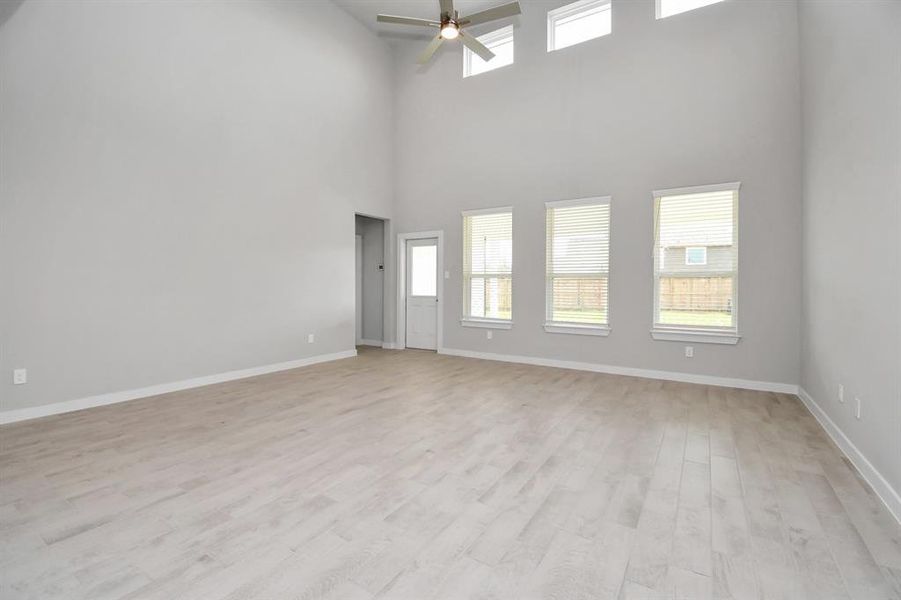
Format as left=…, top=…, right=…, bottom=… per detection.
left=438, top=348, right=798, bottom=394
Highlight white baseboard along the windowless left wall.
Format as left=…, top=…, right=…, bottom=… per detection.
left=0, top=350, right=357, bottom=425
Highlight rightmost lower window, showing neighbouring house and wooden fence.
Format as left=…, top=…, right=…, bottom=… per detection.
left=652, top=183, right=739, bottom=344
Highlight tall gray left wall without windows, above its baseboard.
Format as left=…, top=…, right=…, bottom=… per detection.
left=0, top=0, right=394, bottom=410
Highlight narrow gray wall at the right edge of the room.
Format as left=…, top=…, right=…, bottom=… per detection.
left=800, top=0, right=901, bottom=490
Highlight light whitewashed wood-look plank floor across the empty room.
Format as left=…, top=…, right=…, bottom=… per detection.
left=0, top=350, right=901, bottom=600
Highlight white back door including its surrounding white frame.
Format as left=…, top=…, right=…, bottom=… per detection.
left=397, top=231, right=445, bottom=351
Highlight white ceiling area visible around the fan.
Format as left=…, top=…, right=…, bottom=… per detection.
left=334, top=0, right=510, bottom=39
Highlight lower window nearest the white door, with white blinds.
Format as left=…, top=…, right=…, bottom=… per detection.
left=461, top=207, right=513, bottom=329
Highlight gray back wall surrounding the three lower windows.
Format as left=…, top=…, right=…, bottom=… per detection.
left=396, top=0, right=801, bottom=383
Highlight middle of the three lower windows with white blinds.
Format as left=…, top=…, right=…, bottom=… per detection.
left=545, top=198, right=610, bottom=335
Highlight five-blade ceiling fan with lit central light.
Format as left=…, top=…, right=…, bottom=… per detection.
left=376, top=0, right=522, bottom=64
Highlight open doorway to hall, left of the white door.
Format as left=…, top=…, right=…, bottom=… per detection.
left=354, top=214, right=386, bottom=348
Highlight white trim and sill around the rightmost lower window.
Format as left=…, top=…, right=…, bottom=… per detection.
left=651, top=181, right=741, bottom=345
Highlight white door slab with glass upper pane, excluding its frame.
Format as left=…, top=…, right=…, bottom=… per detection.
left=406, top=238, right=438, bottom=350
